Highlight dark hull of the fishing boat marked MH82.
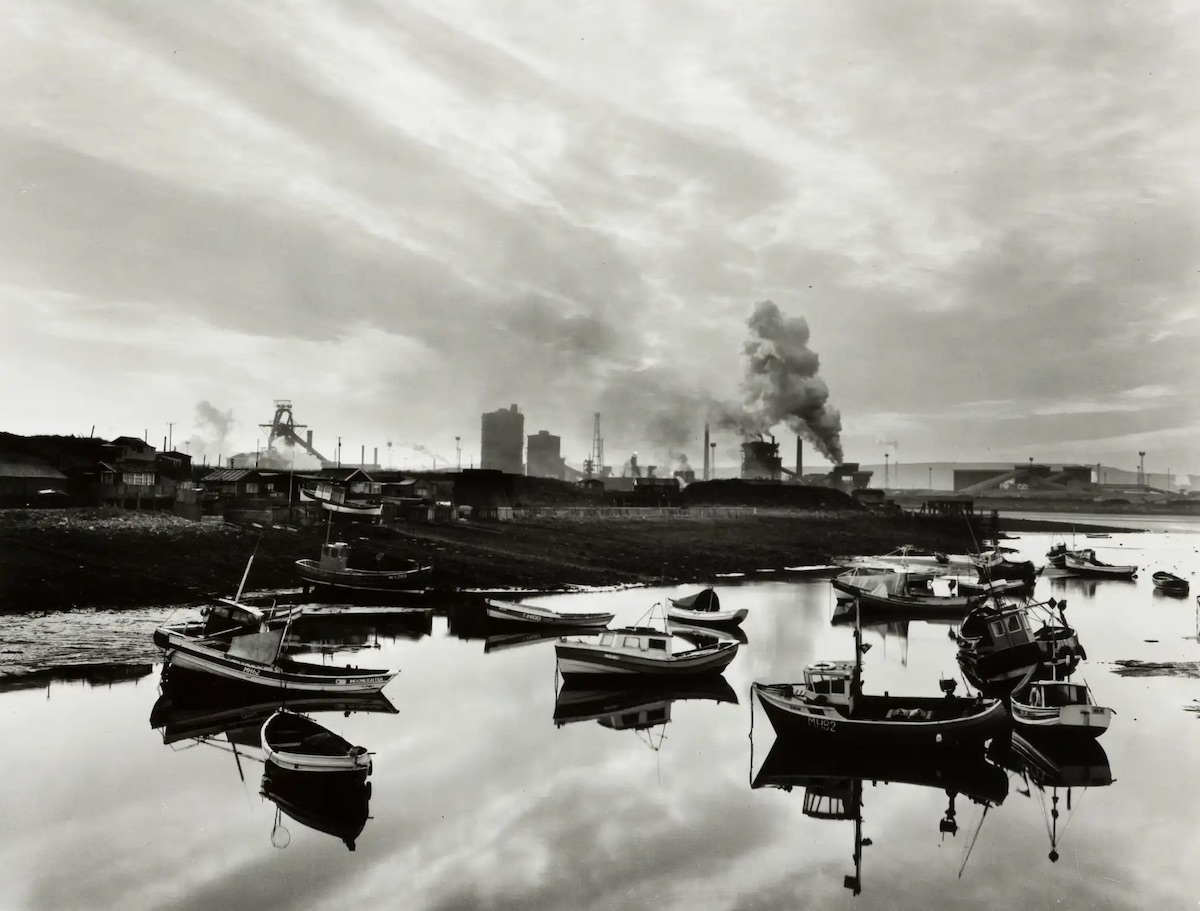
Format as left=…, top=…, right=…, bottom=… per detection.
left=754, top=683, right=1009, bottom=747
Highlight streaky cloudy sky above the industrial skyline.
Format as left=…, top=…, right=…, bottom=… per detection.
left=0, top=0, right=1200, bottom=472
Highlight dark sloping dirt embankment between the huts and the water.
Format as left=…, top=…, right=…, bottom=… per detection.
left=0, top=509, right=993, bottom=611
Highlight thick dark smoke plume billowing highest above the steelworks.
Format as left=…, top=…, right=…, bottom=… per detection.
left=715, top=300, right=842, bottom=465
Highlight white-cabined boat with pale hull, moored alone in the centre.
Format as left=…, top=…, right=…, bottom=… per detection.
left=554, top=627, right=738, bottom=679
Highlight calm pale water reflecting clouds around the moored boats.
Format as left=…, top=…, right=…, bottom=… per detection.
left=0, top=531, right=1200, bottom=911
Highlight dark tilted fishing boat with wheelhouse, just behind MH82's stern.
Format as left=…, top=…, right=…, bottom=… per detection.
left=953, top=603, right=1043, bottom=695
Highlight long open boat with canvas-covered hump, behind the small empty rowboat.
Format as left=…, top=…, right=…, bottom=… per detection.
left=156, top=602, right=397, bottom=694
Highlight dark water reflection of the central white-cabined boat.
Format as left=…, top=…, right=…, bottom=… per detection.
left=554, top=677, right=738, bottom=730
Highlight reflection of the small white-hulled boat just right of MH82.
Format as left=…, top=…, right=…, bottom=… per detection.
left=991, top=731, right=1114, bottom=863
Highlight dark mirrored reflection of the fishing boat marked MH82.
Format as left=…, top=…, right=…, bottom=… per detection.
left=750, top=741, right=1008, bottom=895
